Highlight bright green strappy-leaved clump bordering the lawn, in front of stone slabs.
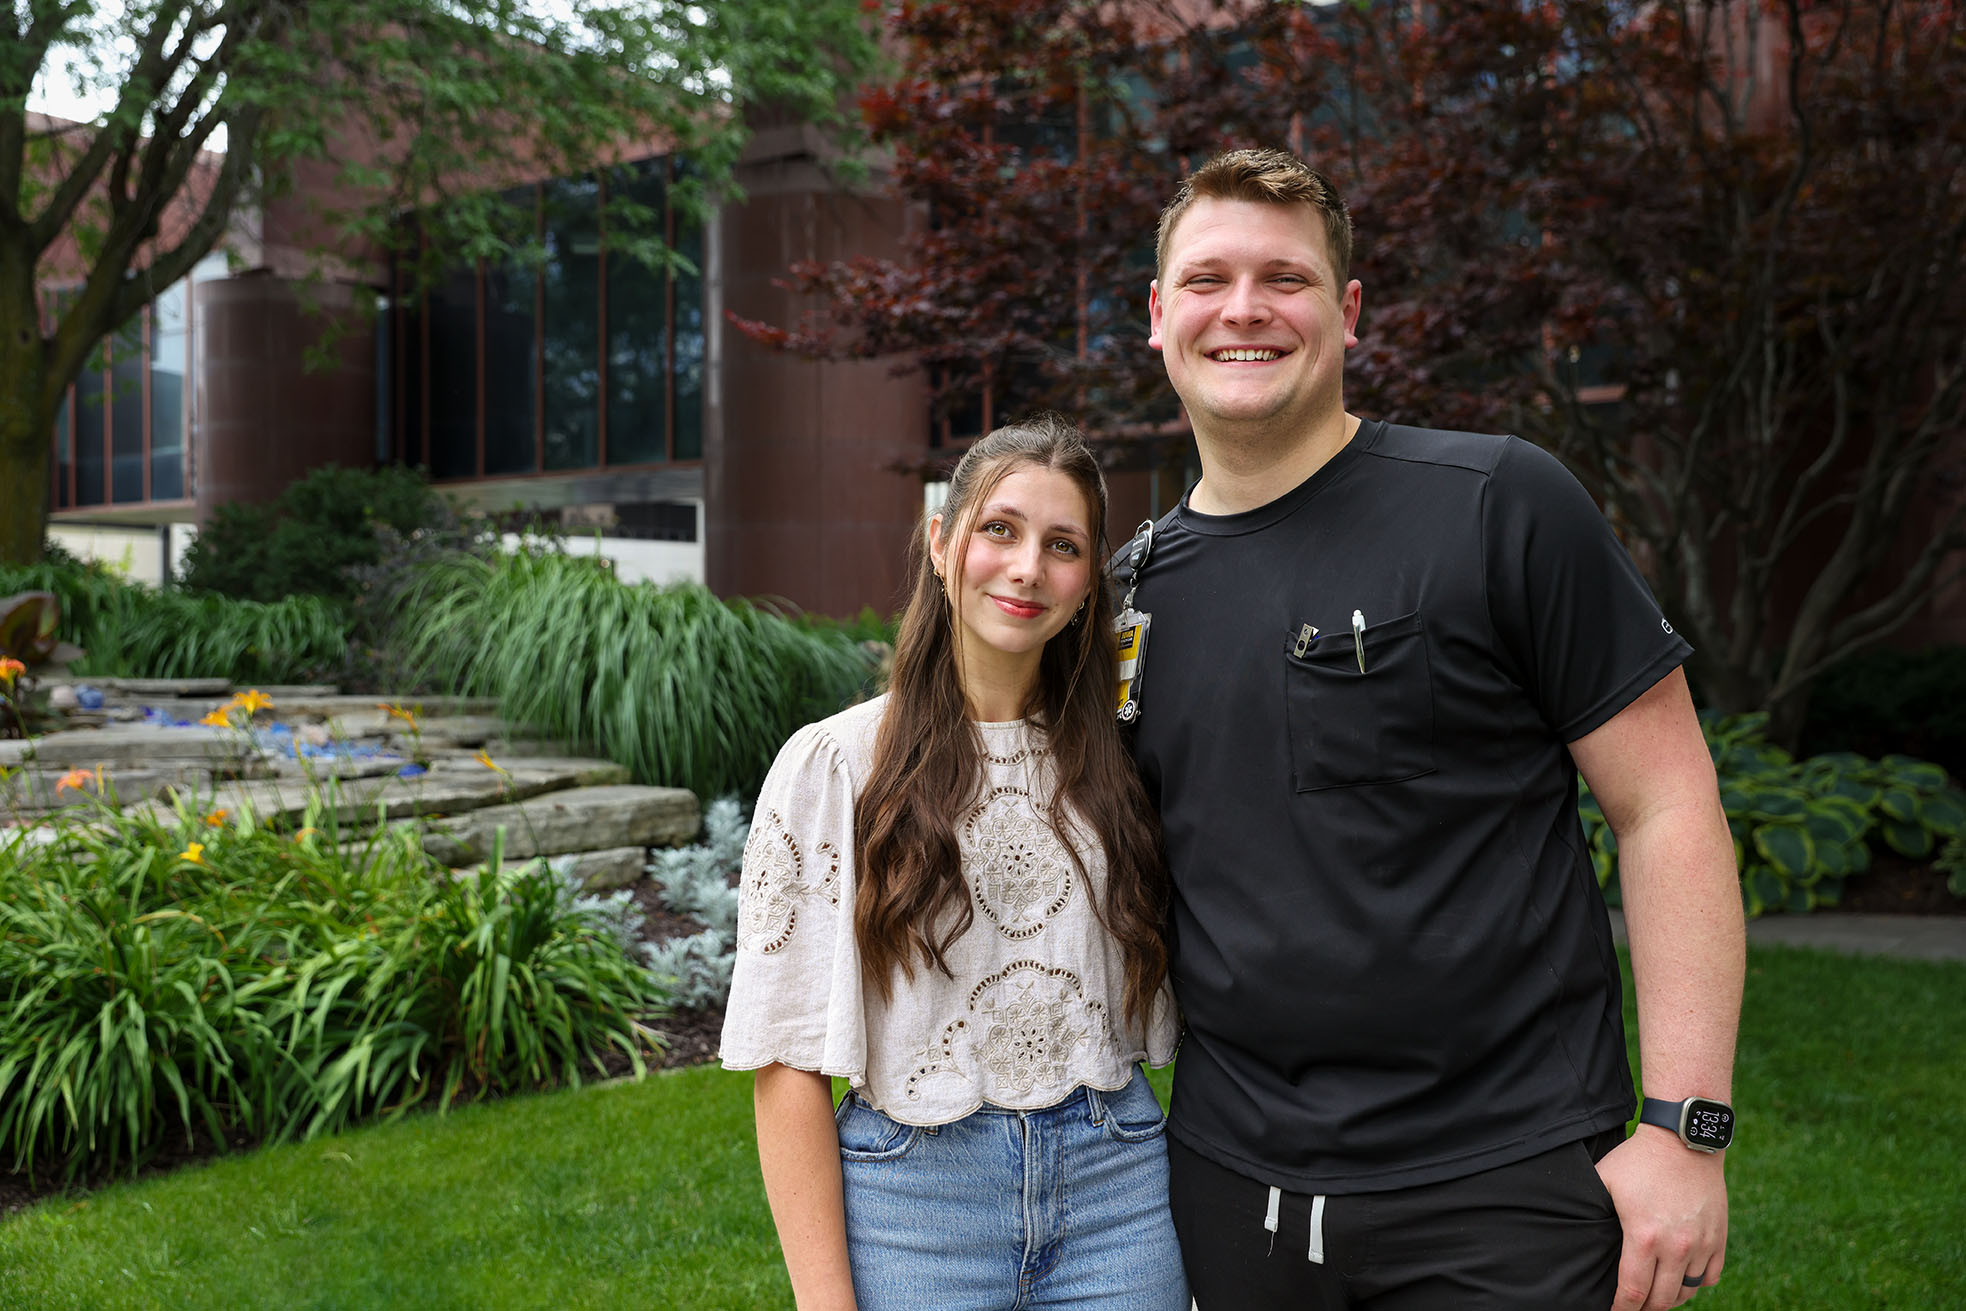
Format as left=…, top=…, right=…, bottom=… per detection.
left=0, top=796, right=665, bottom=1177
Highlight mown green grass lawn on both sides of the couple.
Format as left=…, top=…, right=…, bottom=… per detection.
left=0, top=947, right=1966, bottom=1311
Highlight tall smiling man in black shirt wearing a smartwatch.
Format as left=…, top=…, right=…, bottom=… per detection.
left=1134, top=151, right=1744, bottom=1311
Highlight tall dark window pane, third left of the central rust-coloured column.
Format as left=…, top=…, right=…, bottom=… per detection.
left=541, top=177, right=602, bottom=470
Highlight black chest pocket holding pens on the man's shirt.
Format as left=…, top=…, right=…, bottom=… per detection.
left=1284, top=613, right=1433, bottom=792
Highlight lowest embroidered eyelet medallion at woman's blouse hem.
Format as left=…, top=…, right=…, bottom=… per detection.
left=904, top=961, right=1117, bottom=1101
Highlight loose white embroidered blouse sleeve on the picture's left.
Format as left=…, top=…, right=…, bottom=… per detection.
left=720, top=723, right=867, bottom=1083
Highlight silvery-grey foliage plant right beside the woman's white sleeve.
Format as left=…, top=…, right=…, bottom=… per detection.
left=643, top=796, right=751, bottom=1008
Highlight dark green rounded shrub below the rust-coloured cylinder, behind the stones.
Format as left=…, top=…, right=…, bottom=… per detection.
left=183, top=466, right=442, bottom=603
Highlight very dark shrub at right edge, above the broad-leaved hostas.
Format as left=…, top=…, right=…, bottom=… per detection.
left=1801, top=645, right=1966, bottom=778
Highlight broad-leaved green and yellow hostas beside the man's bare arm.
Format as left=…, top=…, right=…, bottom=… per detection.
left=1577, top=713, right=1966, bottom=918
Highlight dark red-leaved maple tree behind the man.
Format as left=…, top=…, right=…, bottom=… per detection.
left=739, top=0, right=1966, bottom=741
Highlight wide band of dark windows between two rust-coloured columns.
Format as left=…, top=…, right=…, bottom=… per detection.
left=391, top=157, right=706, bottom=480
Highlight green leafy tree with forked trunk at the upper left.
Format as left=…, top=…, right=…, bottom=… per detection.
left=0, top=0, right=871, bottom=562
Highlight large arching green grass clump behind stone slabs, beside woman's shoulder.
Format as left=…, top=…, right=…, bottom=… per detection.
left=397, top=550, right=871, bottom=796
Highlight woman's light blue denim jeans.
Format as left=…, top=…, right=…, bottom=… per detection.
left=838, top=1071, right=1187, bottom=1311
